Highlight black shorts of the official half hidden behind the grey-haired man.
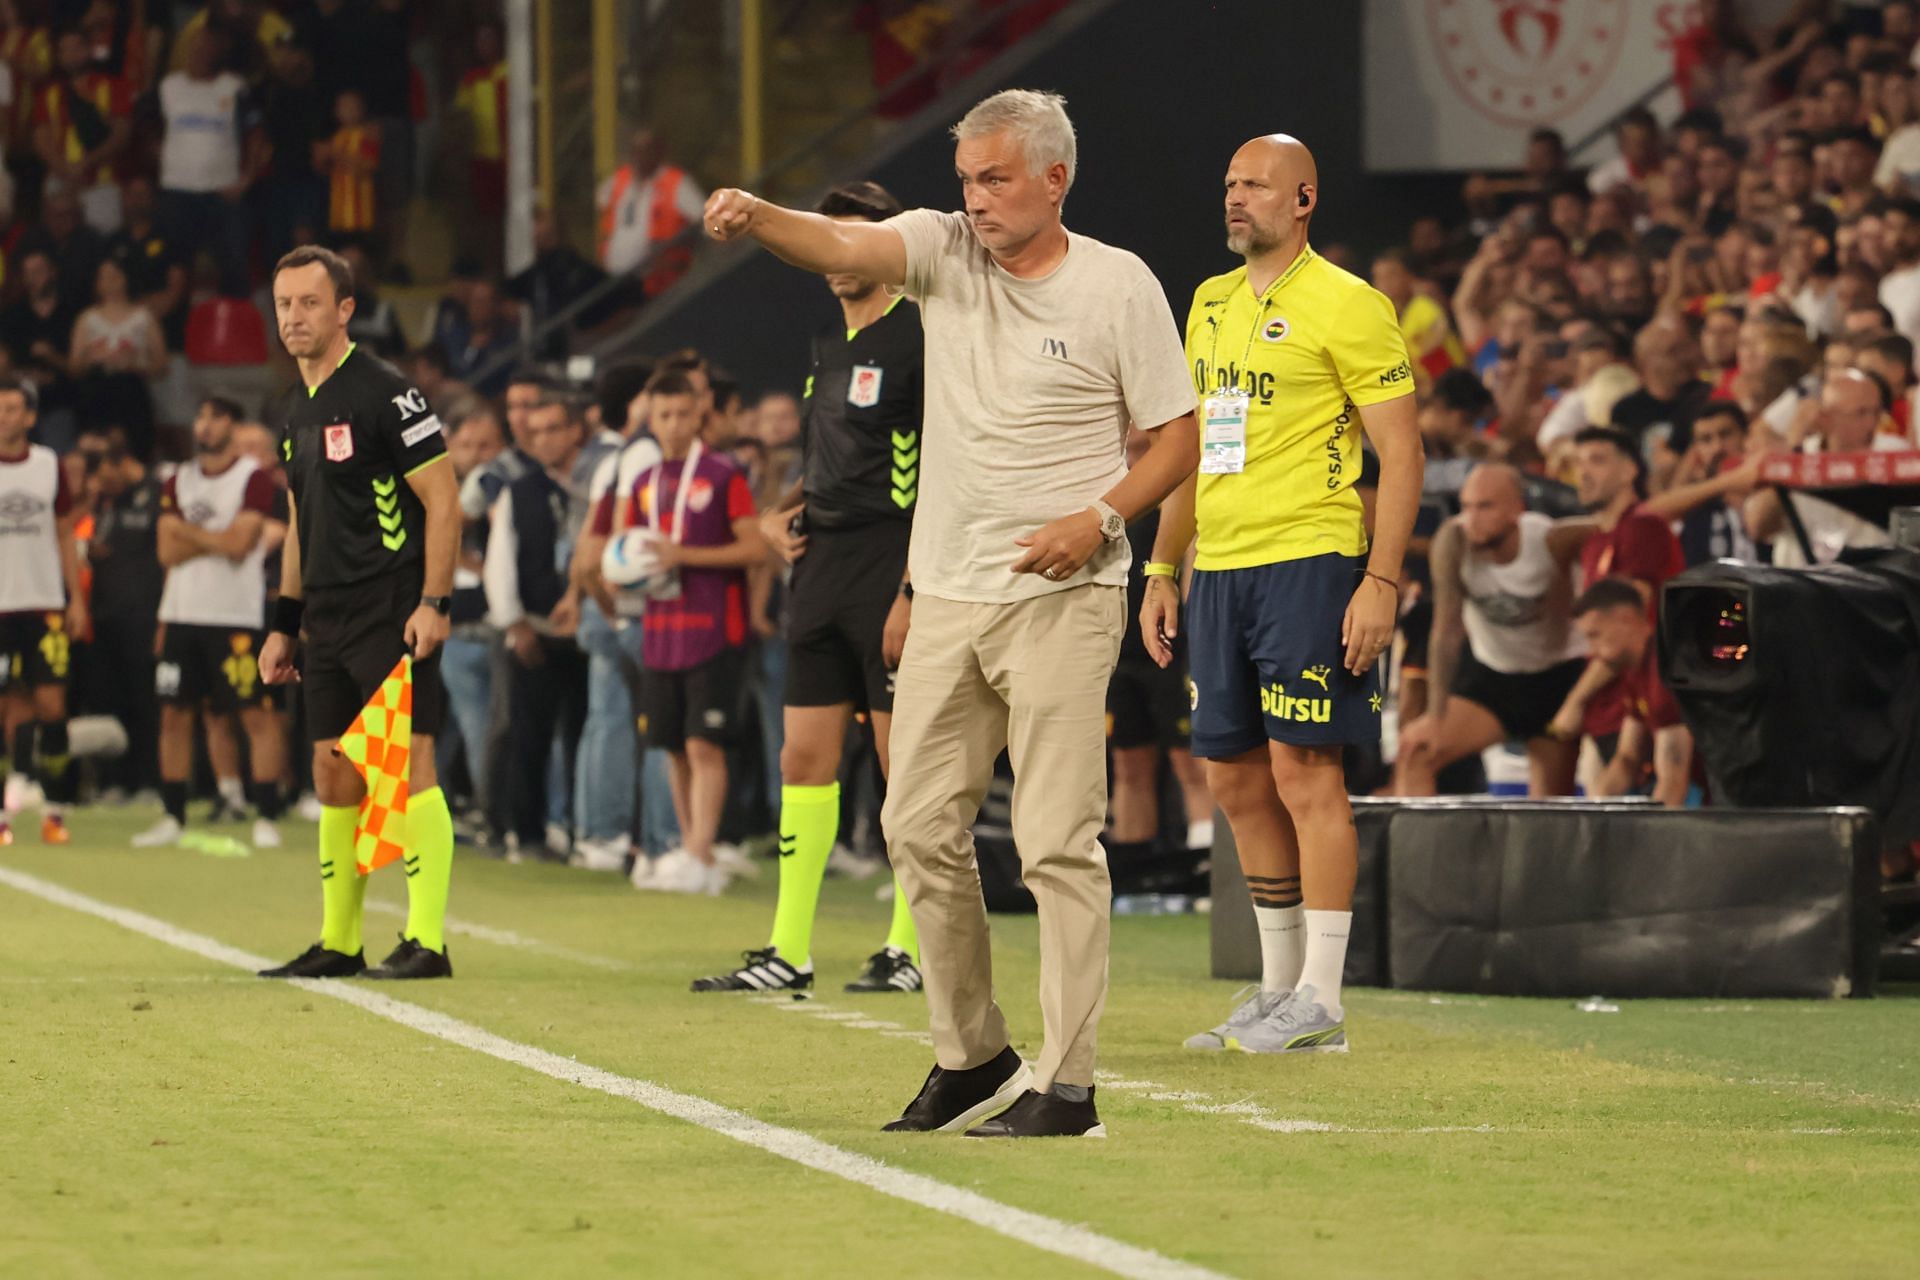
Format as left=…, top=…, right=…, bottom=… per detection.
left=785, top=520, right=912, bottom=712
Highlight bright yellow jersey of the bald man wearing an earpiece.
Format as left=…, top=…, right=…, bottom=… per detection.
left=1187, top=248, right=1413, bottom=570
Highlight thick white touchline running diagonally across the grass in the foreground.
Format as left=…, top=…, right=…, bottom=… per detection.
left=0, top=867, right=1223, bottom=1280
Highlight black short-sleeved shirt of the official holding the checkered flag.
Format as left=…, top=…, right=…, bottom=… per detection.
left=278, top=347, right=447, bottom=587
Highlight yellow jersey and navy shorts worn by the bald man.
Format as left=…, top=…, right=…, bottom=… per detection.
left=1187, top=248, right=1413, bottom=760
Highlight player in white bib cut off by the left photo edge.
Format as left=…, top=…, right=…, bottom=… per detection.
left=0, top=376, right=90, bottom=846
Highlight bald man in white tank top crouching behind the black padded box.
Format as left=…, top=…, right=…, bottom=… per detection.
left=1394, top=462, right=1594, bottom=796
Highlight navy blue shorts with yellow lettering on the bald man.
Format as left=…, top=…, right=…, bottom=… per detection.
left=1187, top=555, right=1380, bottom=760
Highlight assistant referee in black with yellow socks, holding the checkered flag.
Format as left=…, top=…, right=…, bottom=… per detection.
left=259, top=246, right=461, bottom=979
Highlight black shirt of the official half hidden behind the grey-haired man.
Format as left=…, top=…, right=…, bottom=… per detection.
left=801, top=297, right=925, bottom=530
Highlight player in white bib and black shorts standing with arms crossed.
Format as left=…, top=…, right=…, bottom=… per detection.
left=132, top=395, right=286, bottom=848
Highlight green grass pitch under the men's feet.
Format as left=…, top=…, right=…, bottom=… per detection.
left=0, top=810, right=1920, bottom=1280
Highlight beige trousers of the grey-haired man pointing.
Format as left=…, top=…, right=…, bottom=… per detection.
left=881, top=585, right=1127, bottom=1090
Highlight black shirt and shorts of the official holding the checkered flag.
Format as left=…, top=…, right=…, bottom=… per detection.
left=280, top=347, right=447, bottom=743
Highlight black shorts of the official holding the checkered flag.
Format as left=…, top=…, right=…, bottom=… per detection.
left=300, top=566, right=447, bottom=743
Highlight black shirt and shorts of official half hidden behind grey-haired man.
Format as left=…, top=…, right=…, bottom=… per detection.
left=785, top=299, right=924, bottom=712
